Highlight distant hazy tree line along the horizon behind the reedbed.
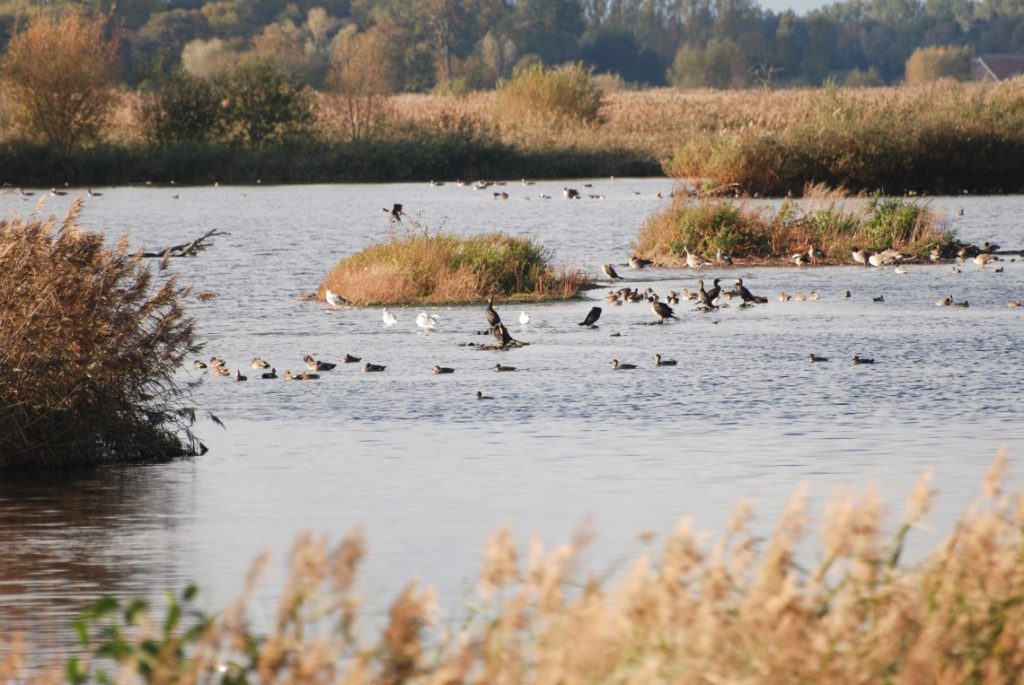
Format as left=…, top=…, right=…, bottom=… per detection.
left=0, top=0, right=1024, bottom=93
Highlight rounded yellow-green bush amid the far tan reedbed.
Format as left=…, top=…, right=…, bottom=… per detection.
left=498, top=63, right=603, bottom=125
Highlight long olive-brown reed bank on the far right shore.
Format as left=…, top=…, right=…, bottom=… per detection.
left=667, top=81, right=1024, bottom=196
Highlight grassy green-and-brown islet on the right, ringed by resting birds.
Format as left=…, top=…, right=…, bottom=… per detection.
left=634, top=186, right=953, bottom=266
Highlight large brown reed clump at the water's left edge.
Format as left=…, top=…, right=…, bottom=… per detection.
left=0, top=194, right=202, bottom=467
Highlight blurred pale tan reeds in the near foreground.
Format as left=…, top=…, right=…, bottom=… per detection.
left=14, top=455, right=1024, bottom=685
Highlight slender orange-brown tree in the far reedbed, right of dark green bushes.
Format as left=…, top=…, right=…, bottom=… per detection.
left=327, top=29, right=396, bottom=140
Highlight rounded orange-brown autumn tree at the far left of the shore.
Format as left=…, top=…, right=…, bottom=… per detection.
left=0, top=11, right=117, bottom=151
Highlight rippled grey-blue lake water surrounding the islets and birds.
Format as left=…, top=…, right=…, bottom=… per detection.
left=0, top=179, right=1024, bottom=661
